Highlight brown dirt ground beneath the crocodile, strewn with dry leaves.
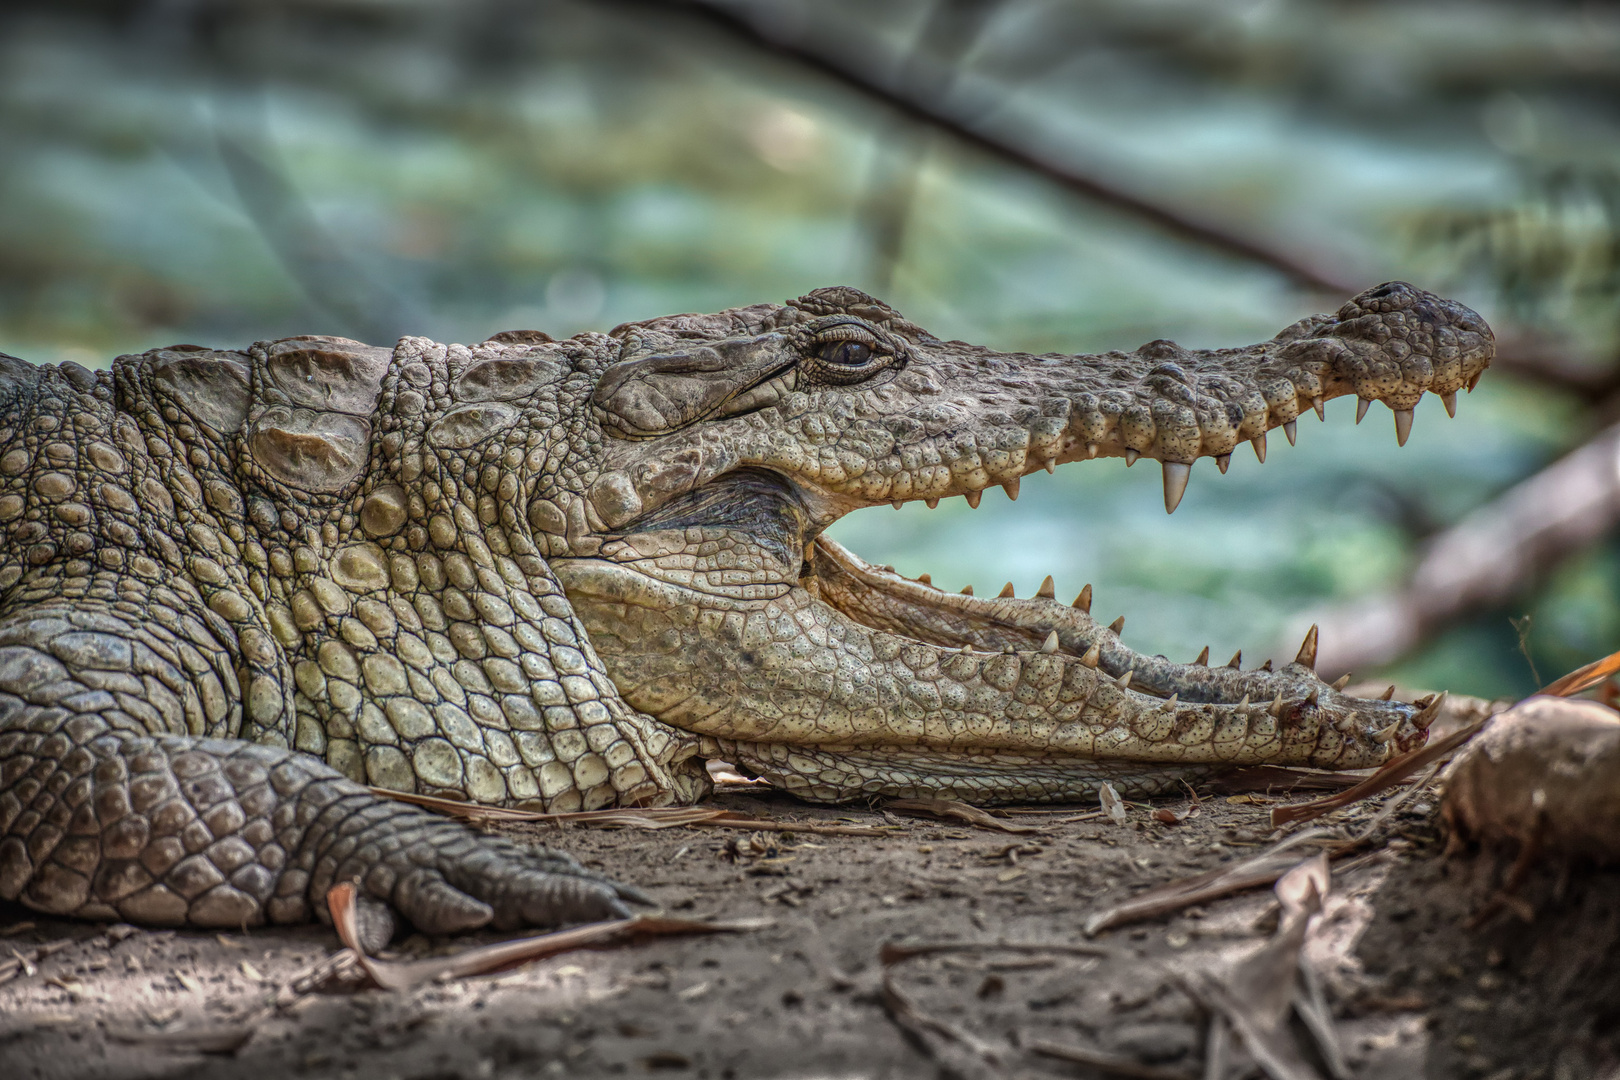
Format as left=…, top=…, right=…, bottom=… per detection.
left=0, top=777, right=1620, bottom=1080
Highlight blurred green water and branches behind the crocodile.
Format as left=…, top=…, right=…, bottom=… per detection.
left=0, top=0, right=1620, bottom=696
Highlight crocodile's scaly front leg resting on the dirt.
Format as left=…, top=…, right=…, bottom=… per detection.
left=0, top=601, right=630, bottom=946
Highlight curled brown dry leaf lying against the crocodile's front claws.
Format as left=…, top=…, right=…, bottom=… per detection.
left=326, top=881, right=771, bottom=989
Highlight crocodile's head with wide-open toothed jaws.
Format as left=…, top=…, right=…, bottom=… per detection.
left=528, top=283, right=1494, bottom=801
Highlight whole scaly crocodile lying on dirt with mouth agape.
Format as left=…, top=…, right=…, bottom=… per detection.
left=0, top=282, right=1494, bottom=941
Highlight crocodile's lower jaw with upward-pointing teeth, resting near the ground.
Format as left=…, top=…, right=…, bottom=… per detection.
left=552, top=541, right=1422, bottom=803
